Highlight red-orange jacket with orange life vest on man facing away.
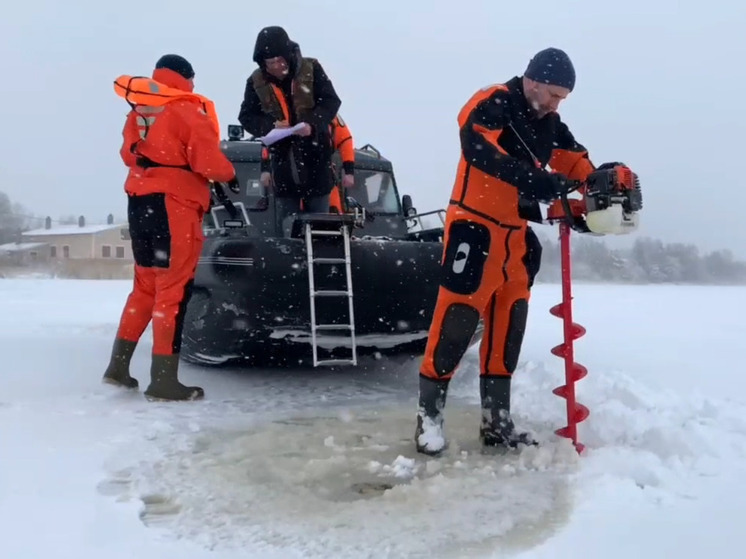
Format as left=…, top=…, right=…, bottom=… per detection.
left=114, top=68, right=236, bottom=211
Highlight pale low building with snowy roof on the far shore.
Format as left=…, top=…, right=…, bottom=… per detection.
left=20, top=214, right=134, bottom=263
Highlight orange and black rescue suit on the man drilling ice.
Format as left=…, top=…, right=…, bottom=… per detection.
left=420, top=77, right=593, bottom=381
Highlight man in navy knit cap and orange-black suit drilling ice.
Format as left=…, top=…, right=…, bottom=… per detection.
left=415, top=48, right=608, bottom=455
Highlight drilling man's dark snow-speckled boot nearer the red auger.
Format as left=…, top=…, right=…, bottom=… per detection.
left=479, top=376, right=538, bottom=448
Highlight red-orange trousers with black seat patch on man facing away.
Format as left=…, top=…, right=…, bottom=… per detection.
left=117, top=194, right=204, bottom=355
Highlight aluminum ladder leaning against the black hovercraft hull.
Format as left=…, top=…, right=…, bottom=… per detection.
left=305, top=221, right=357, bottom=367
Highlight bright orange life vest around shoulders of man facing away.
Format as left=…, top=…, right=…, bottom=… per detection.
left=114, top=75, right=220, bottom=138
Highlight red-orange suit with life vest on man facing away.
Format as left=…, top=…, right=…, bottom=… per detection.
left=108, top=68, right=235, bottom=355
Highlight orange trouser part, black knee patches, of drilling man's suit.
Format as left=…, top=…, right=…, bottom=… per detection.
left=420, top=205, right=541, bottom=380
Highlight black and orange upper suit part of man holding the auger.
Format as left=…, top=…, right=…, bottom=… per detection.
left=451, top=77, right=594, bottom=222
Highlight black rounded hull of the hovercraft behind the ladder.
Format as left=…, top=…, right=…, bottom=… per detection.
left=181, top=233, right=443, bottom=366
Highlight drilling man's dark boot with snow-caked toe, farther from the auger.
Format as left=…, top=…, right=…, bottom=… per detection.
left=414, top=375, right=449, bottom=456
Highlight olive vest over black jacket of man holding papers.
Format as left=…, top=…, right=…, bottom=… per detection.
left=251, top=58, right=316, bottom=122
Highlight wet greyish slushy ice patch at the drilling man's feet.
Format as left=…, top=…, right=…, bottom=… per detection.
left=104, top=400, right=577, bottom=557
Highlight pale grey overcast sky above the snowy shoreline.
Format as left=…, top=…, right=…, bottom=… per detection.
left=0, top=0, right=746, bottom=257
